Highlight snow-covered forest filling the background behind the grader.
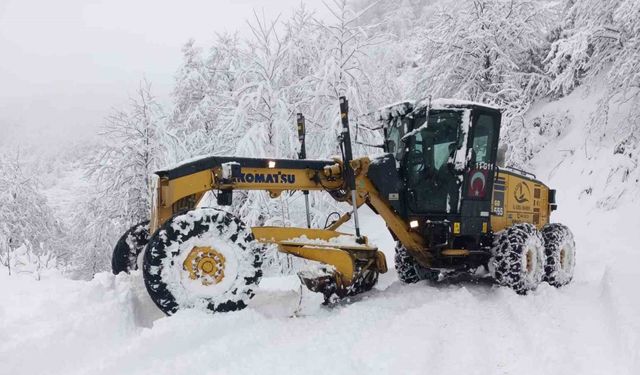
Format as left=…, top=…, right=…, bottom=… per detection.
left=0, top=0, right=640, bottom=278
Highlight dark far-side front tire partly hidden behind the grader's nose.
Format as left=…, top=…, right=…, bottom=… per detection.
left=111, top=220, right=149, bottom=275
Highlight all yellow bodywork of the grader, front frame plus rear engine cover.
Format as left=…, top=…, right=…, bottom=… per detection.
left=151, top=149, right=550, bottom=285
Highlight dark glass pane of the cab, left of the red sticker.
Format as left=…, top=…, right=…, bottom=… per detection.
left=407, top=110, right=462, bottom=213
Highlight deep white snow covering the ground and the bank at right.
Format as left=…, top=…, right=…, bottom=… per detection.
left=0, top=92, right=640, bottom=375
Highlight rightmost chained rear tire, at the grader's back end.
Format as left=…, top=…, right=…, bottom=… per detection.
left=542, top=223, right=576, bottom=288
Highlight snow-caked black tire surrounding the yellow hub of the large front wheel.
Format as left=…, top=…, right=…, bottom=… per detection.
left=142, top=208, right=264, bottom=315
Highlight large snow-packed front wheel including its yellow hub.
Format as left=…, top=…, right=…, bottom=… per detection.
left=143, top=208, right=263, bottom=315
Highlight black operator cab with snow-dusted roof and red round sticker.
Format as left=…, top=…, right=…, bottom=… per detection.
left=379, top=99, right=501, bottom=258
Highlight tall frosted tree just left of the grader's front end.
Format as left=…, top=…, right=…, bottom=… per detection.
left=72, top=82, right=164, bottom=277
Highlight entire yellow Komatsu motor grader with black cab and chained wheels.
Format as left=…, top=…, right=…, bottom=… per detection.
left=112, top=97, right=575, bottom=314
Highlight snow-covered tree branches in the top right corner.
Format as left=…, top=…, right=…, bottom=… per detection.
left=545, top=0, right=640, bottom=154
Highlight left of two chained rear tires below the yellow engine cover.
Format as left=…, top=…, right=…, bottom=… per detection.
left=488, top=223, right=544, bottom=294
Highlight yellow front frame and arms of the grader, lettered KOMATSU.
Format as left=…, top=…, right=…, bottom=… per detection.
left=151, top=157, right=427, bottom=285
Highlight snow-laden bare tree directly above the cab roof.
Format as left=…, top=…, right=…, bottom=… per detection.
left=414, top=0, right=552, bottom=115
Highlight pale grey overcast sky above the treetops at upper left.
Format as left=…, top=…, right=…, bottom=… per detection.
left=0, top=0, right=327, bottom=151
